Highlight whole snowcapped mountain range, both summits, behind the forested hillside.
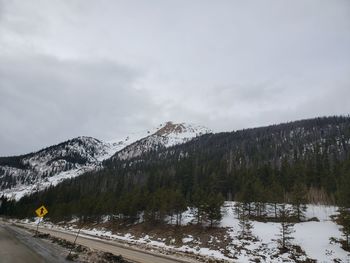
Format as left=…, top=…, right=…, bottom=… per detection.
left=0, top=122, right=210, bottom=199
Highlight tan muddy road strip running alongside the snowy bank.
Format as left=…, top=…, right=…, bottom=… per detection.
left=15, top=225, right=198, bottom=263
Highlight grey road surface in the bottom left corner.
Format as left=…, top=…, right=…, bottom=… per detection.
left=0, top=222, right=66, bottom=263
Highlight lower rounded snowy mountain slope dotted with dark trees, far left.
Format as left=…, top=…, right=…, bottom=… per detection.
left=0, top=137, right=109, bottom=199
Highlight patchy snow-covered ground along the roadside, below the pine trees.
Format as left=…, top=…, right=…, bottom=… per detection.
left=14, top=202, right=350, bottom=263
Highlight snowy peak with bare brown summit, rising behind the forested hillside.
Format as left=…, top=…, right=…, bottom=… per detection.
left=112, top=122, right=211, bottom=160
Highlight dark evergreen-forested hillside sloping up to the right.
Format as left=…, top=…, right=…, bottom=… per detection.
left=2, top=117, right=350, bottom=220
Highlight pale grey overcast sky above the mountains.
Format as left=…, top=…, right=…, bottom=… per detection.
left=0, top=0, right=350, bottom=156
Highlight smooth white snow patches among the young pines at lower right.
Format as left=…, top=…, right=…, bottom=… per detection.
left=221, top=202, right=350, bottom=262
